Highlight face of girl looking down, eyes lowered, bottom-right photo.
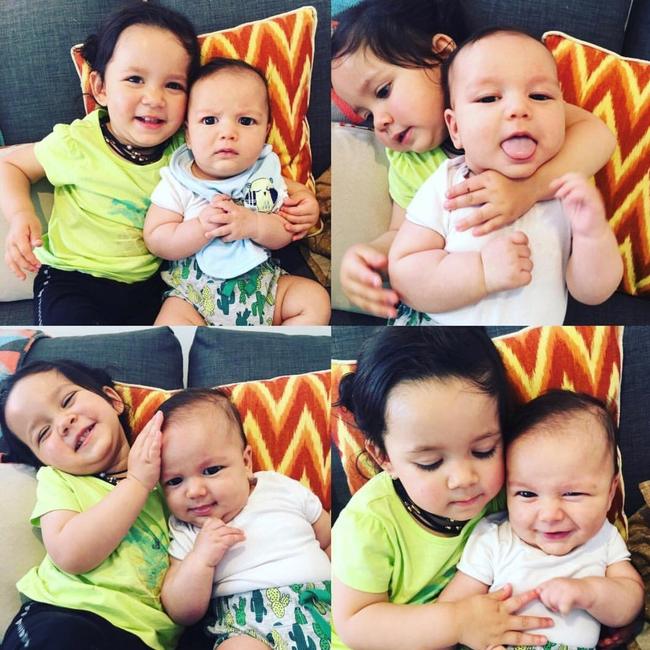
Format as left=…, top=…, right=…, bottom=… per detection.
left=369, top=379, right=504, bottom=520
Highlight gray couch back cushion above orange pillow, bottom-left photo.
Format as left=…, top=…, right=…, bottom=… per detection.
left=187, top=327, right=330, bottom=387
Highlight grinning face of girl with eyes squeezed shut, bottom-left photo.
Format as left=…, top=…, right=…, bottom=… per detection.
left=5, top=370, right=129, bottom=476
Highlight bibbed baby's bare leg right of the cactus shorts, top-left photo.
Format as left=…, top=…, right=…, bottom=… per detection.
left=273, top=275, right=331, bottom=325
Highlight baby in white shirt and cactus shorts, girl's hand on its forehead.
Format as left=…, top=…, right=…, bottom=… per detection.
left=161, top=389, right=330, bottom=650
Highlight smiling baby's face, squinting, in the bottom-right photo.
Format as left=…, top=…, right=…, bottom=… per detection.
left=506, top=413, right=616, bottom=555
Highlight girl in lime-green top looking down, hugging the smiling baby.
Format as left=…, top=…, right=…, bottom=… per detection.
left=332, top=327, right=549, bottom=650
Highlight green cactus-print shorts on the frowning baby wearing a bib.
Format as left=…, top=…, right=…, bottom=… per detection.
left=161, top=256, right=285, bottom=325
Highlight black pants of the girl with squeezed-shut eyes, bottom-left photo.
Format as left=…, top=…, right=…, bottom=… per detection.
left=0, top=600, right=149, bottom=650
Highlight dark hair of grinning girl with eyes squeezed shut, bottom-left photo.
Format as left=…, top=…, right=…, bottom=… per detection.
left=0, top=359, right=131, bottom=468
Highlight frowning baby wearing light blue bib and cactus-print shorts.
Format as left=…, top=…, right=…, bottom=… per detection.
left=144, top=58, right=330, bottom=325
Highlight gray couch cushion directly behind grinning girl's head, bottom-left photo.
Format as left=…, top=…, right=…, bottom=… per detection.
left=21, top=327, right=183, bottom=389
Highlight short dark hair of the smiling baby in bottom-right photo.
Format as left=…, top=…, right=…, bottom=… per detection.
left=504, top=389, right=618, bottom=474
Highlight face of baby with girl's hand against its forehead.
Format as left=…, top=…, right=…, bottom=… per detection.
left=160, top=404, right=253, bottom=528
